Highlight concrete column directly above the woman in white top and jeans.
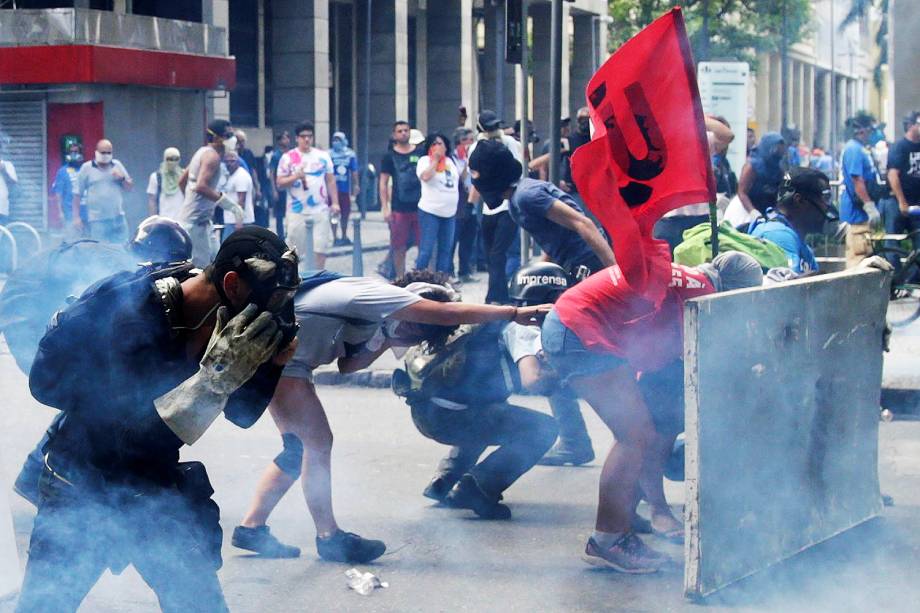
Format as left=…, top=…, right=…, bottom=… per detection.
left=424, top=0, right=470, bottom=137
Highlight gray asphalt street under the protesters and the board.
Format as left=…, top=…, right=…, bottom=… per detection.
left=0, top=347, right=920, bottom=612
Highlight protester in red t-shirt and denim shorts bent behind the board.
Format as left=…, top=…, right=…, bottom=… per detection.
left=542, top=251, right=762, bottom=573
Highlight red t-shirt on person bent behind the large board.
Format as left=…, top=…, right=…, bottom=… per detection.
left=555, top=264, right=716, bottom=371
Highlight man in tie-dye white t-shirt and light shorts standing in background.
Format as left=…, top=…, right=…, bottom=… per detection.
left=275, top=121, right=339, bottom=270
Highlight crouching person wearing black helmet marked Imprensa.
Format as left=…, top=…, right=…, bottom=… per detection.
left=393, top=264, right=564, bottom=519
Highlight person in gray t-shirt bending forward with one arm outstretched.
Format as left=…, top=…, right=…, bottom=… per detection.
left=233, top=272, right=549, bottom=563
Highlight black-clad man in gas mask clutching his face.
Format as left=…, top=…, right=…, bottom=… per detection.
left=18, top=227, right=299, bottom=611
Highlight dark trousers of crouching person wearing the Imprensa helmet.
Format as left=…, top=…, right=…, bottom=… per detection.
left=411, top=400, right=557, bottom=498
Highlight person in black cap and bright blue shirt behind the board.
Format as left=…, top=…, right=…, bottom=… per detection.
left=748, top=166, right=840, bottom=274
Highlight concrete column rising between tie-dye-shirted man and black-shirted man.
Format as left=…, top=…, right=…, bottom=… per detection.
left=355, top=0, right=409, bottom=167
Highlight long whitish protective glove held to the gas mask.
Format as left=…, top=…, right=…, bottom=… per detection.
left=153, top=304, right=281, bottom=445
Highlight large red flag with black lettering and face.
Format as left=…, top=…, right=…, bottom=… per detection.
left=572, top=8, right=715, bottom=302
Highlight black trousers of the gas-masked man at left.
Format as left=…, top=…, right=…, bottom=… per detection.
left=16, top=469, right=228, bottom=612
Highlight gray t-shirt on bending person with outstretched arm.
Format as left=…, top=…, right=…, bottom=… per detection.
left=284, top=277, right=422, bottom=379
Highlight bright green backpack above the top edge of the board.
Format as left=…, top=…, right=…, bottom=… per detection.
left=674, top=221, right=789, bottom=270
